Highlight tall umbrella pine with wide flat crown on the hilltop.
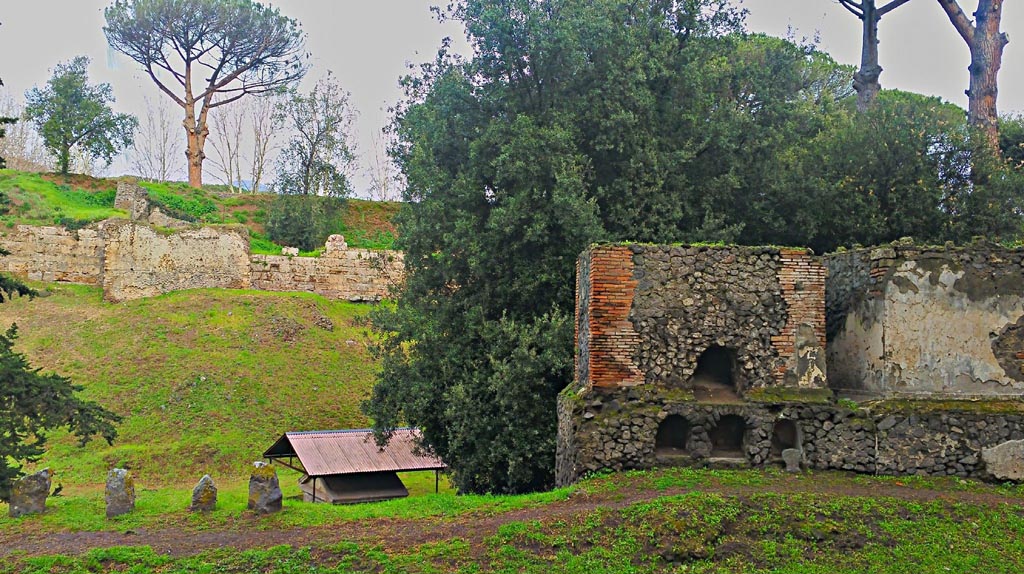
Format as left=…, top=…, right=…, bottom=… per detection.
left=103, top=0, right=306, bottom=187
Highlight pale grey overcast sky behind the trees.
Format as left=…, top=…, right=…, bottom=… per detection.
left=0, top=0, right=1024, bottom=194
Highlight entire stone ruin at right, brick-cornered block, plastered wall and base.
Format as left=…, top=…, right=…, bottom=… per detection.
left=556, top=244, right=1024, bottom=484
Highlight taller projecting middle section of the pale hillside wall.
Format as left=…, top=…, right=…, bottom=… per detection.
left=102, top=221, right=251, bottom=302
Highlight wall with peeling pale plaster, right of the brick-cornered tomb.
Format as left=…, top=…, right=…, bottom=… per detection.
left=826, top=244, right=1024, bottom=399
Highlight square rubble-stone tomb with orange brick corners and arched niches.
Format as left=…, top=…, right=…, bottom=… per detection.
left=556, top=245, right=830, bottom=484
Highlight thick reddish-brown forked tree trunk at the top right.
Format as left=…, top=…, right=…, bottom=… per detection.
left=938, top=0, right=1010, bottom=149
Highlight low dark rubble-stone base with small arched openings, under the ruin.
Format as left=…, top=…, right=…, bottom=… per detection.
left=555, top=388, right=1024, bottom=485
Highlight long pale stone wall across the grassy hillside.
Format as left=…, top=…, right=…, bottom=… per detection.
left=0, top=181, right=403, bottom=302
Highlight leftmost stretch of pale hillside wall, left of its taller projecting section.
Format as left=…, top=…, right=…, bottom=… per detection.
left=0, top=225, right=104, bottom=285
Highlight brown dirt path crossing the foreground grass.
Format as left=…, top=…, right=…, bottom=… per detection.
left=0, top=477, right=1022, bottom=558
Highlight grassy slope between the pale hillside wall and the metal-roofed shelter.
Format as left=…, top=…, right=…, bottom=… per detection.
left=0, top=284, right=376, bottom=492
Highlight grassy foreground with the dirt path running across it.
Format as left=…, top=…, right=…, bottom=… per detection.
left=0, top=469, right=1024, bottom=574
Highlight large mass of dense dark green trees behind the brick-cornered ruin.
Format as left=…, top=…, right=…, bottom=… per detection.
left=364, top=0, right=1020, bottom=492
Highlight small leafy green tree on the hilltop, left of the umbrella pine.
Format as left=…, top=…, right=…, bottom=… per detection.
left=25, top=56, right=138, bottom=174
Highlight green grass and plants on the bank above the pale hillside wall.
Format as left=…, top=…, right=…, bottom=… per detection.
left=0, top=170, right=400, bottom=255
